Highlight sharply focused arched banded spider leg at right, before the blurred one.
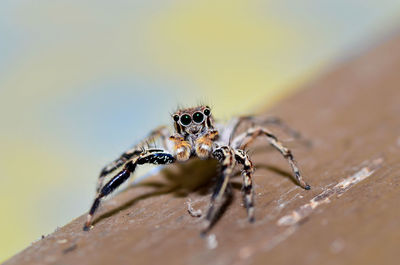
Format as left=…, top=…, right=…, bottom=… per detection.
left=232, top=128, right=311, bottom=190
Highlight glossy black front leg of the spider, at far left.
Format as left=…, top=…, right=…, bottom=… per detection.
left=83, top=149, right=175, bottom=231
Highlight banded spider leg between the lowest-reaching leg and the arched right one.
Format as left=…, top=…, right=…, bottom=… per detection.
left=235, top=149, right=254, bottom=223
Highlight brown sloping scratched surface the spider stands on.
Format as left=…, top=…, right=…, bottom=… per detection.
left=5, top=34, right=400, bottom=265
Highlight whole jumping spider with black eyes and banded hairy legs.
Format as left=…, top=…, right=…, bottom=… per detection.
left=83, top=106, right=310, bottom=231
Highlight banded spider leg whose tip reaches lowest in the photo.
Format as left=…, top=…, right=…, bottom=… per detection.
left=202, top=146, right=235, bottom=234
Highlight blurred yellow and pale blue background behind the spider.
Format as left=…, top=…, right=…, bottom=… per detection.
left=0, top=0, right=400, bottom=262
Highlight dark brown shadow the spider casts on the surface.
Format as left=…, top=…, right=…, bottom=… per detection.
left=93, top=159, right=297, bottom=229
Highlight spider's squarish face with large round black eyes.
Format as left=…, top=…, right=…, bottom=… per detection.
left=172, top=106, right=213, bottom=135
